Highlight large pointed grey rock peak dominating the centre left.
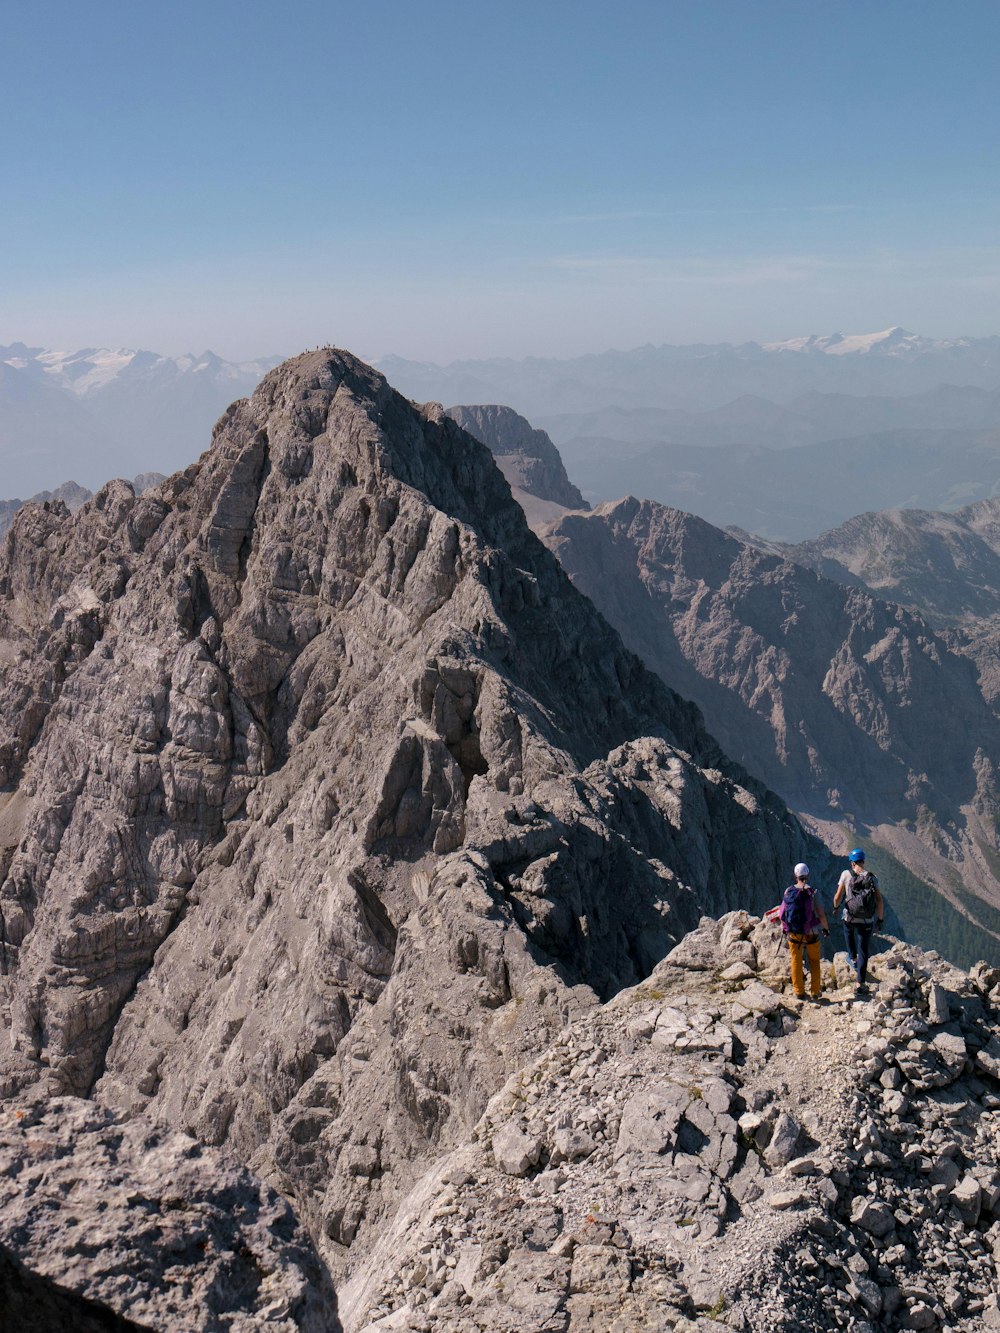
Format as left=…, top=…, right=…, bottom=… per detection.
left=0, top=351, right=825, bottom=1314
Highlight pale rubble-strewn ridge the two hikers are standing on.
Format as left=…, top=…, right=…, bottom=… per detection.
left=341, top=912, right=1000, bottom=1333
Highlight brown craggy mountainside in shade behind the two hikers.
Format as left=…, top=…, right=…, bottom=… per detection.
left=543, top=499, right=1000, bottom=922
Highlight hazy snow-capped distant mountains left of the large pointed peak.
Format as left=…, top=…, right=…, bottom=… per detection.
left=0, top=343, right=280, bottom=496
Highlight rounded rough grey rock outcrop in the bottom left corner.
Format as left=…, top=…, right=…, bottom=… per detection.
left=0, top=1097, right=340, bottom=1333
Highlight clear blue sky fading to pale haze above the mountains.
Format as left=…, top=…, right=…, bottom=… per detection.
left=0, top=0, right=1000, bottom=361
